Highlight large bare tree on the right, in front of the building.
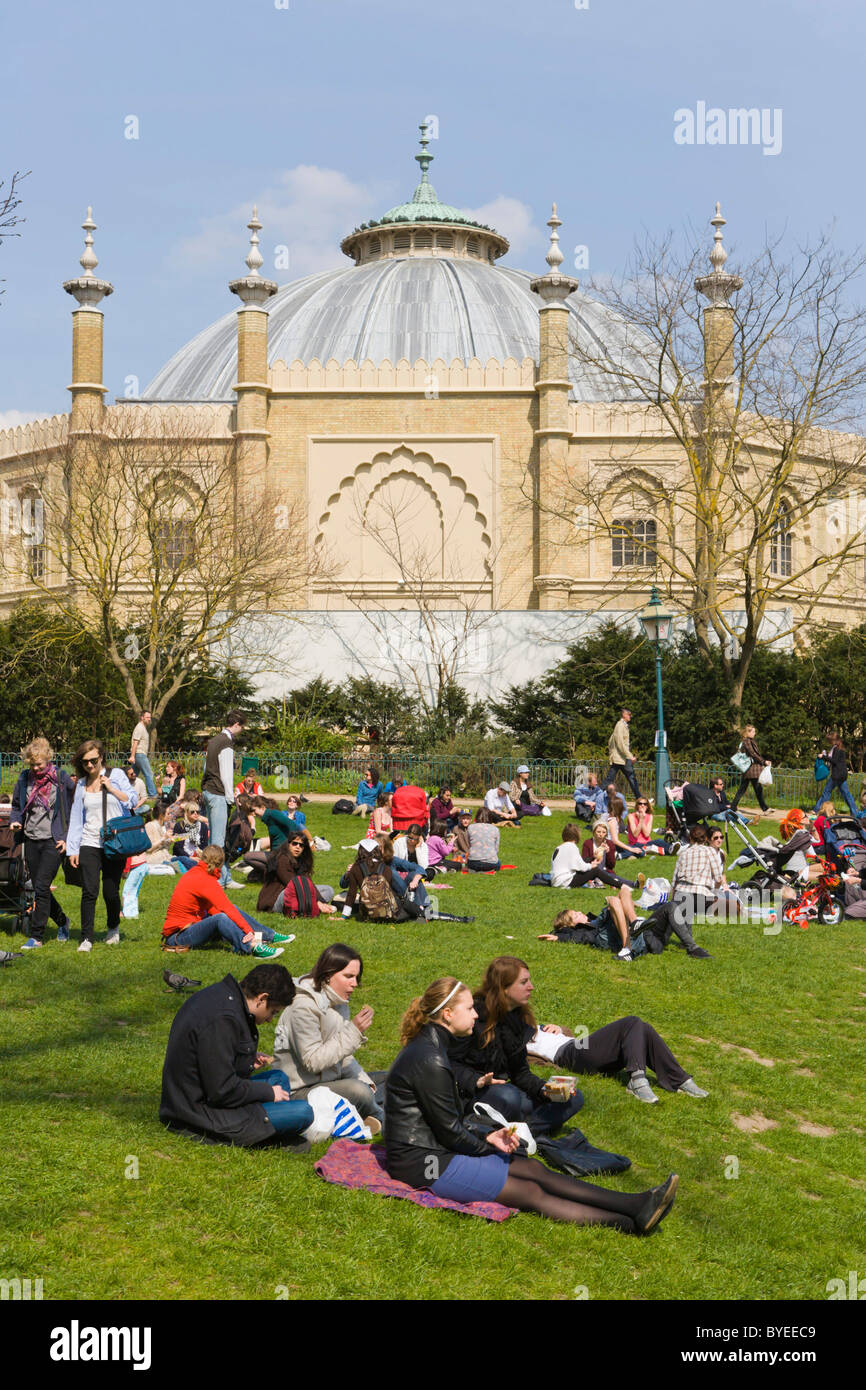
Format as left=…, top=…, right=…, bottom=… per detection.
left=525, top=219, right=866, bottom=713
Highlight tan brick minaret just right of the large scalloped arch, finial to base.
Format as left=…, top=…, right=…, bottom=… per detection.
left=530, top=203, right=577, bottom=609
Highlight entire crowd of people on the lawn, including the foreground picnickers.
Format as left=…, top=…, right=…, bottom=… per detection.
left=6, top=710, right=866, bottom=1234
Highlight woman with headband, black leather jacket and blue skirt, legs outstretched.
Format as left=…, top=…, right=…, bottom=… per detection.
left=385, top=976, right=678, bottom=1234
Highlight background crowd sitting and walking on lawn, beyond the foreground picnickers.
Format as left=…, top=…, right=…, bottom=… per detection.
left=10, top=710, right=866, bottom=959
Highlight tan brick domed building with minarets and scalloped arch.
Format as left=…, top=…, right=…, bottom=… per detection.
left=0, top=125, right=861, bottom=694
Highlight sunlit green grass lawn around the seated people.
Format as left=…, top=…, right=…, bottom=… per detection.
left=0, top=805, right=866, bottom=1300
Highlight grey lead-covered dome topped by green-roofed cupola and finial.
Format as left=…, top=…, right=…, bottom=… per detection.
left=143, top=126, right=648, bottom=402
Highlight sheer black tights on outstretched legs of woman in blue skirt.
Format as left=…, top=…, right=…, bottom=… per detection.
left=496, top=1158, right=646, bottom=1236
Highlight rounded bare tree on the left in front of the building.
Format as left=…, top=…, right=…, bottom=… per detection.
left=3, top=404, right=323, bottom=719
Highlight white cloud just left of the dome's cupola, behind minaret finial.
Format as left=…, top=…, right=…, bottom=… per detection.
left=170, top=164, right=388, bottom=284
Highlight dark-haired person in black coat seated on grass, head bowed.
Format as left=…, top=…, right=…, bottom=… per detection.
left=160, top=965, right=313, bottom=1152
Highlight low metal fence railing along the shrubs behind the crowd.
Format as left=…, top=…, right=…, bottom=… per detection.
left=0, top=749, right=866, bottom=806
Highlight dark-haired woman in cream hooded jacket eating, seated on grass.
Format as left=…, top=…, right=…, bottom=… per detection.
left=274, top=941, right=384, bottom=1133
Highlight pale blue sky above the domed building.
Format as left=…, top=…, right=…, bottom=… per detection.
left=0, top=0, right=866, bottom=425
